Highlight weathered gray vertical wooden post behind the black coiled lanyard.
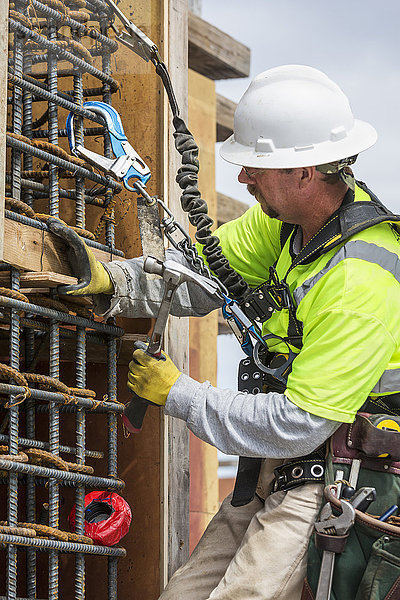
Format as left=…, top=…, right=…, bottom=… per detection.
left=161, top=0, right=189, bottom=587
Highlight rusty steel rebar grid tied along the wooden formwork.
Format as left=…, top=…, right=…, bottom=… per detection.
left=0, top=0, right=125, bottom=600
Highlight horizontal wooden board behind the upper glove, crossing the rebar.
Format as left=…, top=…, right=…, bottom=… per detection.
left=3, top=219, right=121, bottom=276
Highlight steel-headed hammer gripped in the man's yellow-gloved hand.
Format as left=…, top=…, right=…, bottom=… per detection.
left=122, top=256, right=222, bottom=433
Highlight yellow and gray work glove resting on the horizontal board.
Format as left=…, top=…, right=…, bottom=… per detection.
left=46, top=217, right=114, bottom=296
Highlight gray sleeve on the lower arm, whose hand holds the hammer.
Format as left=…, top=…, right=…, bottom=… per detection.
left=165, top=375, right=341, bottom=458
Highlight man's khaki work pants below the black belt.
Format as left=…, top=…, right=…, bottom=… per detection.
left=159, top=460, right=323, bottom=600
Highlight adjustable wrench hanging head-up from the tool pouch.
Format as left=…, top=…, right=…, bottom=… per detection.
left=315, top=500, right=355, bottom=600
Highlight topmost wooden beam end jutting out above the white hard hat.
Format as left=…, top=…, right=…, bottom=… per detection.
left=188, top=13, right=250, bottom=79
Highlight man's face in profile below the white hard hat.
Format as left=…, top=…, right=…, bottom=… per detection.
left=238, top=167, right=297, bottom=223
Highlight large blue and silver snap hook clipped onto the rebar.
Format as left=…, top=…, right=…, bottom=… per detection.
left=66, top=100, right=151, bottom=192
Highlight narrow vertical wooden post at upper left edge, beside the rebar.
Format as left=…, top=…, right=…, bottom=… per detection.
left=0, top=1, right=8, bottom=259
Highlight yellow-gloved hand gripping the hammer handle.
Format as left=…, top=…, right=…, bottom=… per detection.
left=128, top=350, right=181, bottom=406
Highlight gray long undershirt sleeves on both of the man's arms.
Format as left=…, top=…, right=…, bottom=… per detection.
left=94, top=250, right=341, bottom=458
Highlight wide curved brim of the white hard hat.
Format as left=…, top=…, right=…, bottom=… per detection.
left=220, top=119, right=378, bottom=169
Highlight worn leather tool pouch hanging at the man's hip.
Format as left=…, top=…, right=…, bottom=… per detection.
left=302, top=413, right=400, bottom=600
